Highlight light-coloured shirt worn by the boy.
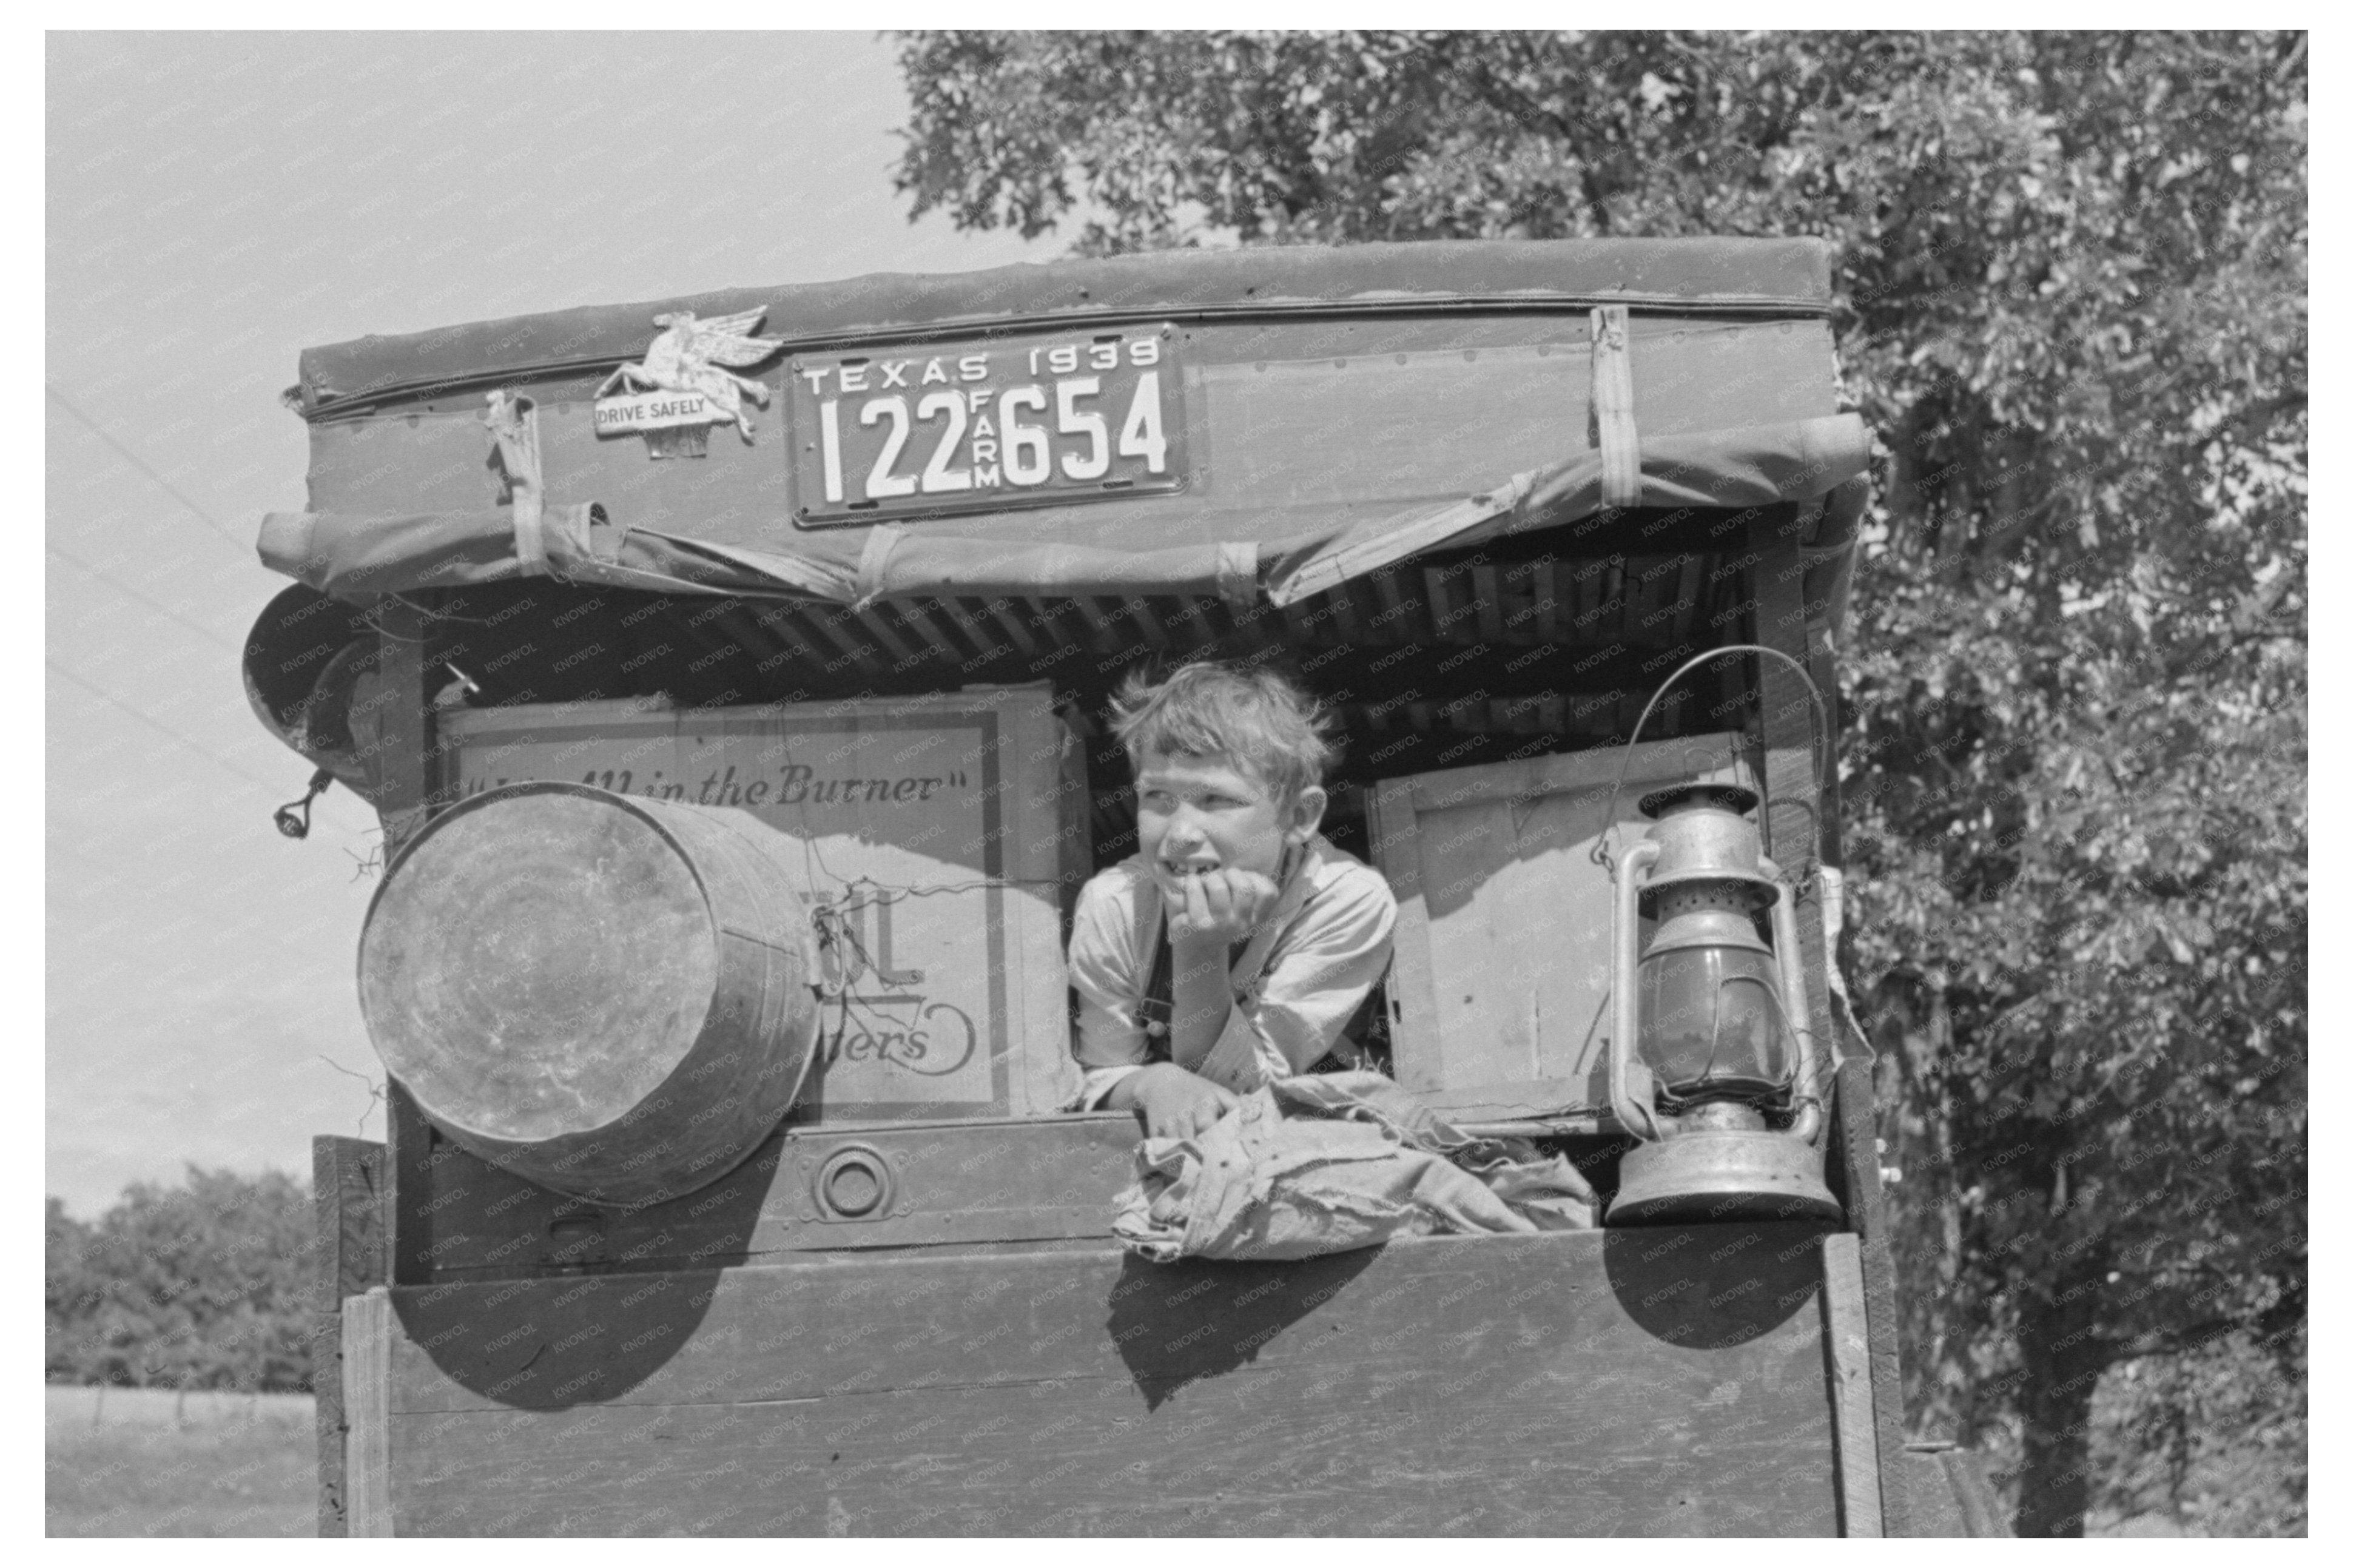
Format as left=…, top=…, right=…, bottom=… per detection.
left=1071, top=836, right=1398, bottom=1111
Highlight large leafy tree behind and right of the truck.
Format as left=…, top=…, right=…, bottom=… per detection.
left=897, top=33, right=2308, bottom=1535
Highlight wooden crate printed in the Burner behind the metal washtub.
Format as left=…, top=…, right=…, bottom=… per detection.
left=442, top=685, right=1089, bottom=1121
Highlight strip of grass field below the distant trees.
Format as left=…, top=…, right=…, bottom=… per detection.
left=47, top=1387, right=318, bottom=1535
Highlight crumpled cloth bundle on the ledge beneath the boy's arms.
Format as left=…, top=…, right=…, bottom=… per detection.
left=1111, top=1071, right=1595, bottom=1262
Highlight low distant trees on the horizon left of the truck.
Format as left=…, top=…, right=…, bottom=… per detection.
left=47, top=1165, right=311, bottom=1391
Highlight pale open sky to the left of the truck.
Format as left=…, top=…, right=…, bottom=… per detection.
left=42, top=33, right=1063, bottom=1217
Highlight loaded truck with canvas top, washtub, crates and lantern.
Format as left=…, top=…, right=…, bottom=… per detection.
left=244, top=238, right=2000, bottom=1535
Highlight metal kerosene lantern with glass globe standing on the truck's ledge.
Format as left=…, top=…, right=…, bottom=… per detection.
left=1609, top=784, right=1840, bottom=1224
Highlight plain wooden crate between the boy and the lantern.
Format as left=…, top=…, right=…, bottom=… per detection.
left=1367, top=735, right=1758, bottom=1121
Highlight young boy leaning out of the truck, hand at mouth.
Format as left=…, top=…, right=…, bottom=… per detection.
left=1071, top=662, right=1398, bottom=1137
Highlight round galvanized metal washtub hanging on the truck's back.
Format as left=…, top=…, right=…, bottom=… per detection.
left=360, top=782, right=819, bottom=1208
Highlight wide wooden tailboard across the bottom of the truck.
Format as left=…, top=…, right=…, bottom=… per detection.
left=393, top=1226, right=1837, bottom=1535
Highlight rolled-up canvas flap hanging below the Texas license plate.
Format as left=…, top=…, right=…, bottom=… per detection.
left=259, top=414, right=1871, bottom=603
